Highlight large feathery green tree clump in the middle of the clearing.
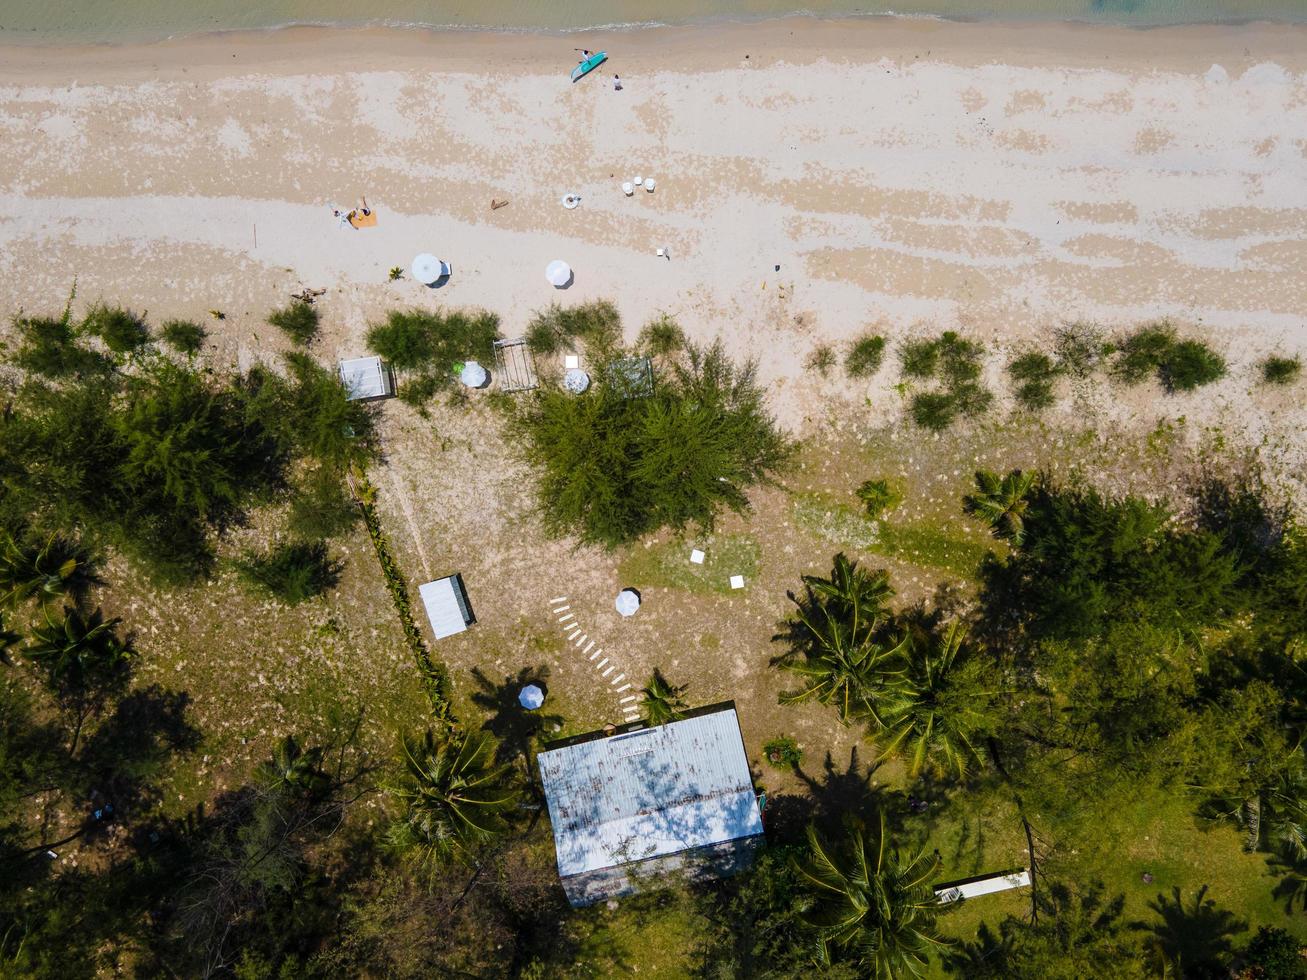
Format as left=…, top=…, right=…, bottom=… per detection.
left=516, top=345, right=791, bottom=547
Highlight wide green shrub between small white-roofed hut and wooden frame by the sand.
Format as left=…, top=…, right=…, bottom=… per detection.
left=367, top=308, right=499, bottom=406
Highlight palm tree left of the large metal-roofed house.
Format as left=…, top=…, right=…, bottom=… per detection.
left=389, top=730, right=518, bottom=873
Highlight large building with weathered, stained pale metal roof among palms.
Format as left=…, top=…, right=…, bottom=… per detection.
left=536, top=702, right=762, bottom=906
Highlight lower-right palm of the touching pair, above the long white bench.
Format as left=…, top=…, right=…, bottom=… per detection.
left=881, top=622, right=997, bottom=779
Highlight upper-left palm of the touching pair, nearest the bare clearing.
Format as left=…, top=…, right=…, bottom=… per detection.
left=771, top=553, right=907, bottom=725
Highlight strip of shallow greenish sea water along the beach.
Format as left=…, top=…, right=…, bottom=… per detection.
left=0, top=0, right=1307, bottom=43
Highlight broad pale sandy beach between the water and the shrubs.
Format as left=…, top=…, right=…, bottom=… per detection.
left=0, top=18, right=1307, bottom=488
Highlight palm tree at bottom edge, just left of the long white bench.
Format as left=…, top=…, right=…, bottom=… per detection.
left=795, top=810, right=945, bottom=977
